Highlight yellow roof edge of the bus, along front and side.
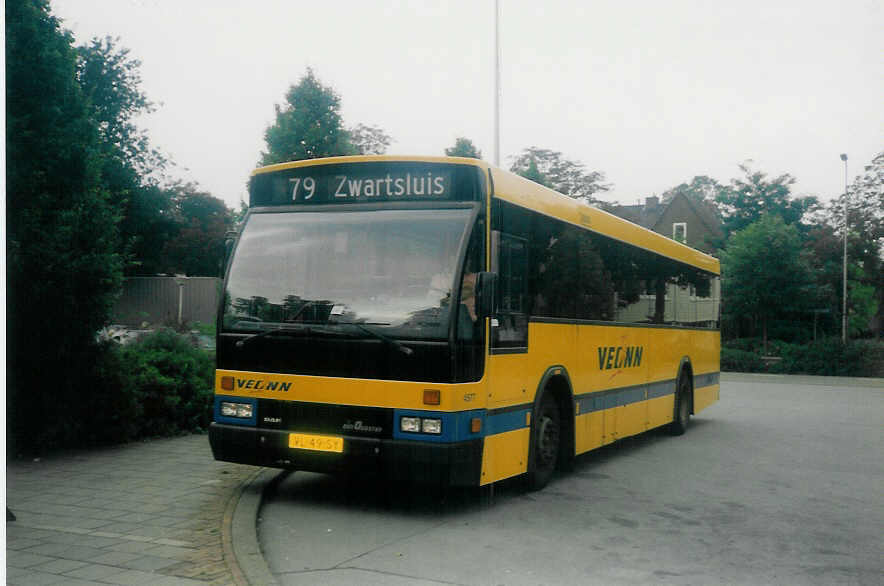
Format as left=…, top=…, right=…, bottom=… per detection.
left=252, top=155, right=721, bottom=275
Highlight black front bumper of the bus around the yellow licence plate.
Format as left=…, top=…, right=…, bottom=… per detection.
left=209, top=423, right=483, bottom=486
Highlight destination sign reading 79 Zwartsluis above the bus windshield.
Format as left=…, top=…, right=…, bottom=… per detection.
left=250, top=163, right=478, bottom=206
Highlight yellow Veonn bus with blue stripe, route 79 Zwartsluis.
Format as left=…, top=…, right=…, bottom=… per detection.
left=210, top=156, right=720, bottom=488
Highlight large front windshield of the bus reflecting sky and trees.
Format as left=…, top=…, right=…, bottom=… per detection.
left=222, top=209, right=471, bottom=340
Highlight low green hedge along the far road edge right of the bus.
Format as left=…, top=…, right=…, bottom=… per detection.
left=721, top=338, right=884, bottom=377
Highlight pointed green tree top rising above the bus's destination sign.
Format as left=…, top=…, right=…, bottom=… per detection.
left=261, top=68, right=357, bottom=165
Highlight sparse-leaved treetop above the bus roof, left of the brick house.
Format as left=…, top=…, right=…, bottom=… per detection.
left=510, top=146, right=611, bottom=204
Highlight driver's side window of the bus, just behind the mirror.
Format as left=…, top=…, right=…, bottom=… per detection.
left=491, top=233, right=528, bottom=349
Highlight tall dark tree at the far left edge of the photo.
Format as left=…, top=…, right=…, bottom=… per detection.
left=6, top=0, right=122, bottom=453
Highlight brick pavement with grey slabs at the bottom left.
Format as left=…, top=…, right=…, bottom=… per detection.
left=6, top=435, right=258, bottom=586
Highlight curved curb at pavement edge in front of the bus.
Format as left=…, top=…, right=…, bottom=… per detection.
left=221, top=468, right=286, bottom=586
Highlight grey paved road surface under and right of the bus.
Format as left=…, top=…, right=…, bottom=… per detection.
left=258, top=376, right=884, bottom=586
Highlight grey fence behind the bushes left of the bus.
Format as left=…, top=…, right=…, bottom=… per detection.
left=112, top=277, right=221, bottom=326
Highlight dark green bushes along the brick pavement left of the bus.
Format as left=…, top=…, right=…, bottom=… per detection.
left=7, top=329, right=215, bottom=457
